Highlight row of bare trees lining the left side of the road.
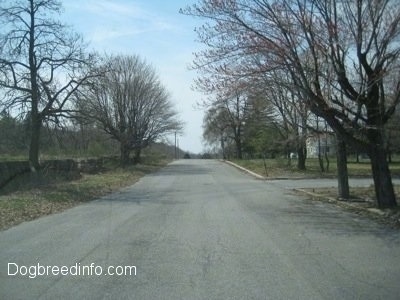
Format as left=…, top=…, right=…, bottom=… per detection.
left=0, top=0, right=183, bottom=172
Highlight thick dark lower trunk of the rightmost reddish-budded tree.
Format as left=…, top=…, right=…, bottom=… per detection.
left=369, top=146, right=397, bottom=208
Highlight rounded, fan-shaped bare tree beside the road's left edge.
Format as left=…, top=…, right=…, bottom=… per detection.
left=81, top=56, right=182, bottom=166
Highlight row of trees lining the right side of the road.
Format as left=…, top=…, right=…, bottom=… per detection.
left=181, top=0, right=400, bottom=207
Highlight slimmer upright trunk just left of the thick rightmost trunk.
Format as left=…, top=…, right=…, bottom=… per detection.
left=336, top=134, right=350, bottom=199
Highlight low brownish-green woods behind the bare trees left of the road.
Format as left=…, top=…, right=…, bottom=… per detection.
left=0, top=110, right=118, bottom=160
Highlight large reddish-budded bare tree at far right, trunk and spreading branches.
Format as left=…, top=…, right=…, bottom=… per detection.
left=183, top=0, right=400, bottom=207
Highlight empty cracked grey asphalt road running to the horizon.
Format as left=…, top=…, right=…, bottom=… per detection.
left=0, top=160, right=400, bottom=299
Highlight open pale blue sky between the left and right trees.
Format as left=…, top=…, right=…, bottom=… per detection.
left=62, top=0, right=203, bottom=153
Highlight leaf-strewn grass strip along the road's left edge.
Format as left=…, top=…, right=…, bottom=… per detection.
left=0, top=160, right=168, bottom=230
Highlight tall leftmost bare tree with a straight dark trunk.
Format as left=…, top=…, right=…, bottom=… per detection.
left=0, top=0, right=94, bottom=171
